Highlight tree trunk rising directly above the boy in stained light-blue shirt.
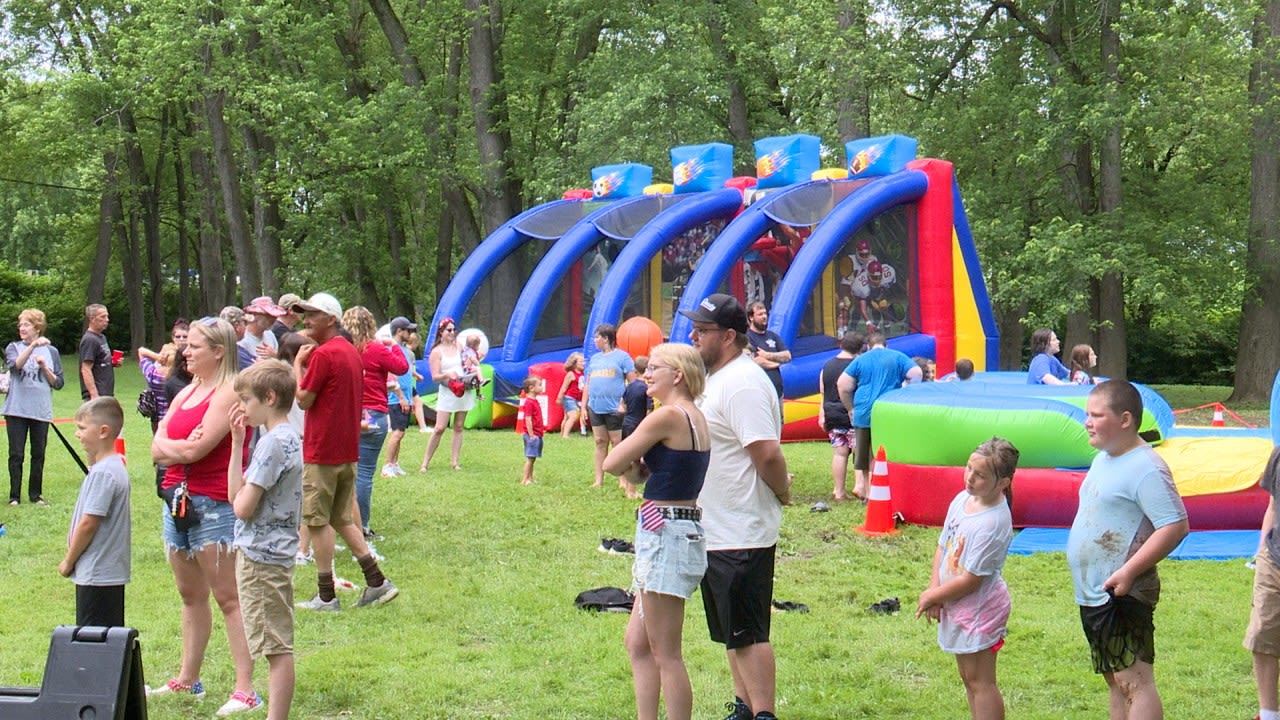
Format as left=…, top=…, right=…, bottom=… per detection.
left=1097, top=0, right=1129, bottom=378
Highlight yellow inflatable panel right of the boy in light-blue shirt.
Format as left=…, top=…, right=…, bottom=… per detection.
left=1156, top=437, right=1274, bottom=497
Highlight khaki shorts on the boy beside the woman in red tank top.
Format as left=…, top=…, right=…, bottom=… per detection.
left=236, top=552, right=293, bottom=657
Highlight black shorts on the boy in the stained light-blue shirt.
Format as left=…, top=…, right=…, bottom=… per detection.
left=1080, top=594, right=1156, bottom=673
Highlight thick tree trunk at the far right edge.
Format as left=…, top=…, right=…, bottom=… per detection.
left=1231, top=0, right=1280, bottom=402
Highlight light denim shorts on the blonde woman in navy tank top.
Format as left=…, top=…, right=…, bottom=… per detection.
left=631, top=512, right=707, bottom=600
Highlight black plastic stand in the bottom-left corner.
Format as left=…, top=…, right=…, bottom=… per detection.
left=0, top=625, right=147, bottom=720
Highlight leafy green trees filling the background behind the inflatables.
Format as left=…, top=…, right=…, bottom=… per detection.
left=0, top=0, right=1264, bottom=397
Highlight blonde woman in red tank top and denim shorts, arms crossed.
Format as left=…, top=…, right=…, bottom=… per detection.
left=150, top=318, right=255, bottom=697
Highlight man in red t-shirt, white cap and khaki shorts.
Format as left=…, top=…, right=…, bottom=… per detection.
left=293, top=292, right=399, bottom=604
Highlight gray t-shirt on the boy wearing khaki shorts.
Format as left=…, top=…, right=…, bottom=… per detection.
left=234, top=423, right=302, bottom=566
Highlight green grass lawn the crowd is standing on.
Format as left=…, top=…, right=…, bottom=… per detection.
left=0, top=366, right=1256, bottom=720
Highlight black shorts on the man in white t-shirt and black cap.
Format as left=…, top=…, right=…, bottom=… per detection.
left=701, top=546, right=777, bottom=650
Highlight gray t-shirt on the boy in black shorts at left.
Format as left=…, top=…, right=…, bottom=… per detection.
left=67, top=454, right=132, bottom=585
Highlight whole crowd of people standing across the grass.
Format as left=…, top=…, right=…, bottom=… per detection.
left=3, top=292, right=1280, bottom=720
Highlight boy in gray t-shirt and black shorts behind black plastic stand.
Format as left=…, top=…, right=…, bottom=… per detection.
left=58, top=397, right=131, bottom=628
